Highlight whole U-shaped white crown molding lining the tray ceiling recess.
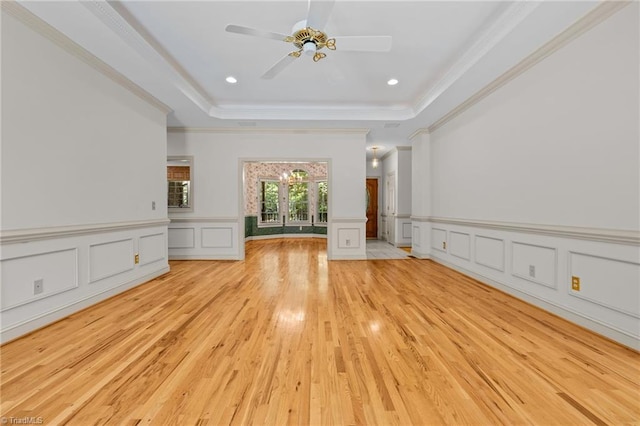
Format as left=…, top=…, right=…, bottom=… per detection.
left=75, top=0, right=539, bottom=121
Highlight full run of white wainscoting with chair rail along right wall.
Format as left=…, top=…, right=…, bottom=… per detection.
left=424, top=217, right=640, bottom=350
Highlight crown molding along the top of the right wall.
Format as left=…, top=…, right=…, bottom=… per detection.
left=427, top=0, right=633, bottom=133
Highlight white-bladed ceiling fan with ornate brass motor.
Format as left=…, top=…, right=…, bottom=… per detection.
left=225, top=0, right=391, bottom=79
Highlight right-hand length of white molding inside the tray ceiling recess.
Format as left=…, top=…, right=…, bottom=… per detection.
left=413, top=1, right=541, bottom=114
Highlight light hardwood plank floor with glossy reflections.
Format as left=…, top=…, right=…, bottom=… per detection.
left=0, top=239, right=640, bottom=425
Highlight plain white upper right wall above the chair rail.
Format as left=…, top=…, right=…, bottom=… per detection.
left=431, top=3, right=640, bottom=230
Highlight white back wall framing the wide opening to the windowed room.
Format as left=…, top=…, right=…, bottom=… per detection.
left=168, top=130, right=366, bottom=259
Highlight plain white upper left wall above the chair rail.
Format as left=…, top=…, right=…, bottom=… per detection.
left=2, top=13, right=167, bottom=230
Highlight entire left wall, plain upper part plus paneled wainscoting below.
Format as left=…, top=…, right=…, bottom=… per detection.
left=0, top=4, right=168, bottom=341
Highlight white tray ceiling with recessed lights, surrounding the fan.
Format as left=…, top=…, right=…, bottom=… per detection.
left=20, top=0, right=598, bottom=155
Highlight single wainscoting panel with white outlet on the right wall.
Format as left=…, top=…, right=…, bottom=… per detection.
left=511, top=242, right=558, bottom=288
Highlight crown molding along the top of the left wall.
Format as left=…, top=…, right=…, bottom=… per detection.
left=0, top=0, right=172, bottom=114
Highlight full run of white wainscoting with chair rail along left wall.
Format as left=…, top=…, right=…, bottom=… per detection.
left=0, top=219, right=169, bottom=342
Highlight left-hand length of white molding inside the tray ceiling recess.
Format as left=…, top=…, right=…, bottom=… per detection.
left=80, top=0, right=213, bottom=114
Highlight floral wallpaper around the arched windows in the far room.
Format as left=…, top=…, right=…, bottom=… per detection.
left=243, top=163, right=327, bottom=216
